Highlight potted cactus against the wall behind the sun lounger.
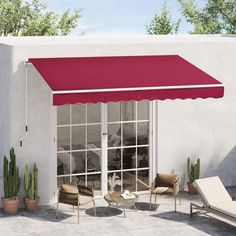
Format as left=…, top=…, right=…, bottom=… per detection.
left=187, top=157, right=200, bottom=194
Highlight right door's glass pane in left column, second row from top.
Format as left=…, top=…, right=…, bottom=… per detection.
left=108, top=124, right=121, bottom=147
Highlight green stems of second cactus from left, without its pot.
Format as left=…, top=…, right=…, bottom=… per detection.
left=24, top=163, right=38, bottom=199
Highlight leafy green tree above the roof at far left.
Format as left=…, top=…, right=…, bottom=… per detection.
left=0, top=0, right=81, bottom=36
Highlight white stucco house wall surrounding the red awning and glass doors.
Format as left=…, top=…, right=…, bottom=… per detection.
left=0, top=36, right=236, bottom=204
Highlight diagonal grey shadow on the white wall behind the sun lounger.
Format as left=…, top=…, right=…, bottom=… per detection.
left=206, top=145, right=236, bottom=186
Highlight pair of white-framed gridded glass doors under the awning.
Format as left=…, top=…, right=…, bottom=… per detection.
left=57, top=101, right=152, bottom=195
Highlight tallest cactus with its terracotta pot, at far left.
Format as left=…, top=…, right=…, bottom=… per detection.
left=2, top=148, right=20, bottom=215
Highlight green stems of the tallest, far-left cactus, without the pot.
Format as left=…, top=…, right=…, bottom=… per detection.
left=3, top=148, right=20, bottom=199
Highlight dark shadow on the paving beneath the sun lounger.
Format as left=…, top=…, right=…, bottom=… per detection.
left=152, top=211, right=236, bottom=235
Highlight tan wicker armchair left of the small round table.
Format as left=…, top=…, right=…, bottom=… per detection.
left=56, top=183, right=96, bottom=223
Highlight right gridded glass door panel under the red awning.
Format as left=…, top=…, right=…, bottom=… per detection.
left=107, top=101, right=150, bottom=192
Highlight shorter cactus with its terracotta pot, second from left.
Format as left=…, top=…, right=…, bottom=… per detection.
left=24, top=163, right=39, bottom=212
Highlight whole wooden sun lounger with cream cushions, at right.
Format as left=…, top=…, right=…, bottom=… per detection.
left=190, top=176, right=236, bottom=223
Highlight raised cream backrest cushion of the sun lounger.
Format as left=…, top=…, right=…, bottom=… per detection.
left=193, top=176, right=232, bottom=206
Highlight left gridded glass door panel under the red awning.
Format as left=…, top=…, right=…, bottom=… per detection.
left=57, top=104, right=101, bottom=194
